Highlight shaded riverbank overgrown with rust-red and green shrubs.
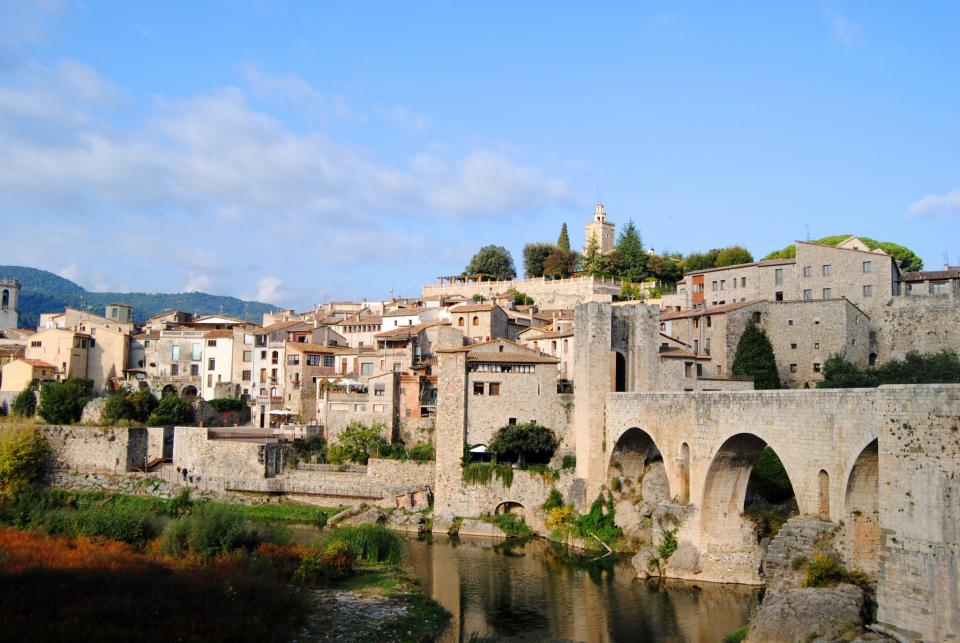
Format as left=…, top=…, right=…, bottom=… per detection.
left=0, top=488, right=449, bottom=641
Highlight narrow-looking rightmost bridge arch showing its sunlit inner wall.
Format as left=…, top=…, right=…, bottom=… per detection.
left=843, top=440, right=880, bottom=575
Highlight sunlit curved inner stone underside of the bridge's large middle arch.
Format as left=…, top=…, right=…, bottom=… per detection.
left=700, top=433, right=802, bottom=547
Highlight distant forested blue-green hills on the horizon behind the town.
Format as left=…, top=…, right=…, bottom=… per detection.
left=0, top=266, right=277, bottom=328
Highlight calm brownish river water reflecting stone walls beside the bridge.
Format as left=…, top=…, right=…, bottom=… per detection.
left=398, top=536, right=759, bottom=643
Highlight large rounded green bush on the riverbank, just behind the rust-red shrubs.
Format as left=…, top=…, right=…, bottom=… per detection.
left=160, top=504, right=249, bottom=558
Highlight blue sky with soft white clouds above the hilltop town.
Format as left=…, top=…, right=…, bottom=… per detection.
left=0, top=0, right=960, bottom=308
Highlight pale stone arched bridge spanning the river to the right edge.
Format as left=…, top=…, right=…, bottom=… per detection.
left=592, top=385, right=960, bottom=636
